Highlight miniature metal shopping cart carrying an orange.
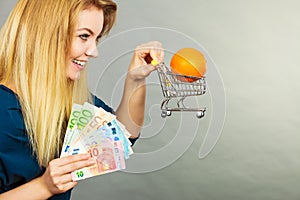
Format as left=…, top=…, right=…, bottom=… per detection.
left=156, top=62, right=206, bottom=118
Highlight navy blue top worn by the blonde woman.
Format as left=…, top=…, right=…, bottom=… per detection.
left=0, top=85, right=136, bottom=200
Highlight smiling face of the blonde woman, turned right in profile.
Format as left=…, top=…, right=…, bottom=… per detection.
left=67, top=7, right=104, bottom=80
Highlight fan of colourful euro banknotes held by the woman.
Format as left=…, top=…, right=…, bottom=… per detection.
left=60, top=102, right=133, bottom=181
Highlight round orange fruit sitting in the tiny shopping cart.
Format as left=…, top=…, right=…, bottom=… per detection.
left=170, top=48, right=206, bottom=82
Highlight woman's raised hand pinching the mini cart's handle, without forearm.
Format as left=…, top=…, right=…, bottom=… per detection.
left=127, top=41, right=164, bottom=81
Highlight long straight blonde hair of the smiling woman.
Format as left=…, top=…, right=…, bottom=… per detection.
left=0, top=0, right=117, bottom=166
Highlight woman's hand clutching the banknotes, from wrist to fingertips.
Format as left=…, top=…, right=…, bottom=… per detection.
left=40, top=154, right=96, bottom=196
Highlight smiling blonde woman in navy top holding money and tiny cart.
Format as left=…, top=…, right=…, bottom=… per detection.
left=0, top=0, right=163, bottom=200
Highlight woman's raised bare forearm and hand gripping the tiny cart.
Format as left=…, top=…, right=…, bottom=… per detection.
left=116, top=41, right=164, bottom=138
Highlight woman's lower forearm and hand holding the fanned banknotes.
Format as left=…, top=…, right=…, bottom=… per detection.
left=0, top=154, right=95, bottom=200
